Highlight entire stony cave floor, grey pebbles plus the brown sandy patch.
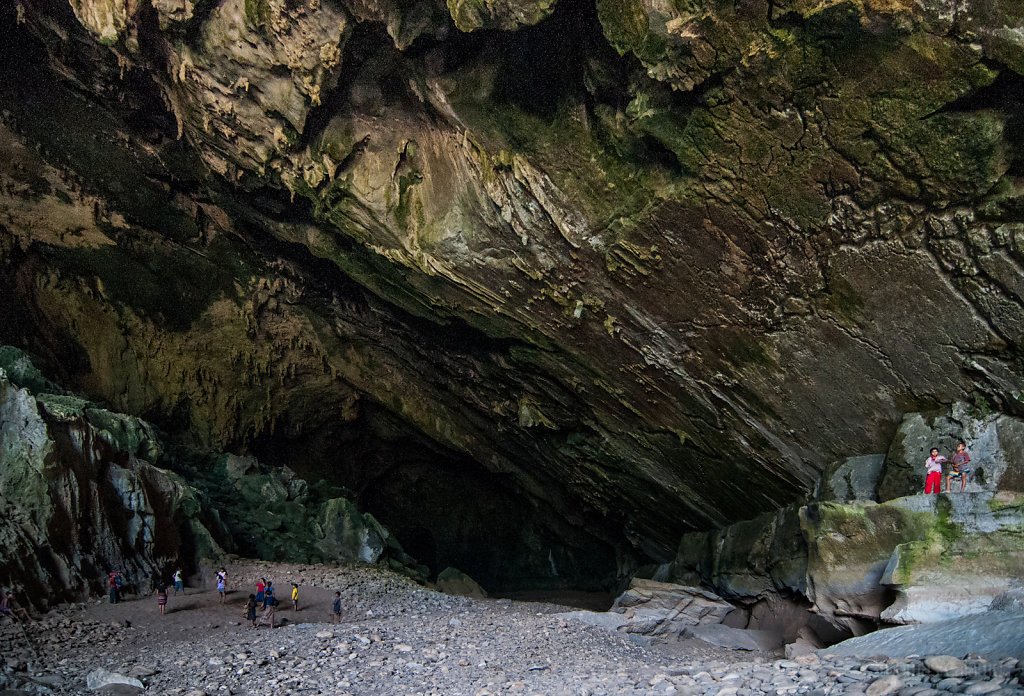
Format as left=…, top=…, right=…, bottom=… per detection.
left=0, top=561, right=1024, bottom=696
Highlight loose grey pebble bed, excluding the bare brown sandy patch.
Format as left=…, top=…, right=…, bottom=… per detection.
left=0, top=560, right=1024, bottom=696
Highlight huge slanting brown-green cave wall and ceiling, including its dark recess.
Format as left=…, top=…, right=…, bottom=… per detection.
left=0, top=0, right=1024, bottom=586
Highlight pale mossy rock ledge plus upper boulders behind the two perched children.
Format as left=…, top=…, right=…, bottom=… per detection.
left=657, top=403, right=1024, bottom=647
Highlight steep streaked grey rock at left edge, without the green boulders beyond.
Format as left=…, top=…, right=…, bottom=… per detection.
left=0, top=352, right=220, bottom=607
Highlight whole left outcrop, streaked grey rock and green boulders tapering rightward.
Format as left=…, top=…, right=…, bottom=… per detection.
left=0, top=346, right=429, bottom=606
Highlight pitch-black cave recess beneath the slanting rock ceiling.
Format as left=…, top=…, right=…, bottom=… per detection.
left=253, top=404, right=624, bottom=593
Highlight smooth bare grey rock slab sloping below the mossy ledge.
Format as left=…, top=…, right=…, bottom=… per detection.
left=817, top=611, right=1024, bottom=660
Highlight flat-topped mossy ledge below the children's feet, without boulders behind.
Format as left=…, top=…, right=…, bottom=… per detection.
left=670, top=492, right=1024, bottom=647
